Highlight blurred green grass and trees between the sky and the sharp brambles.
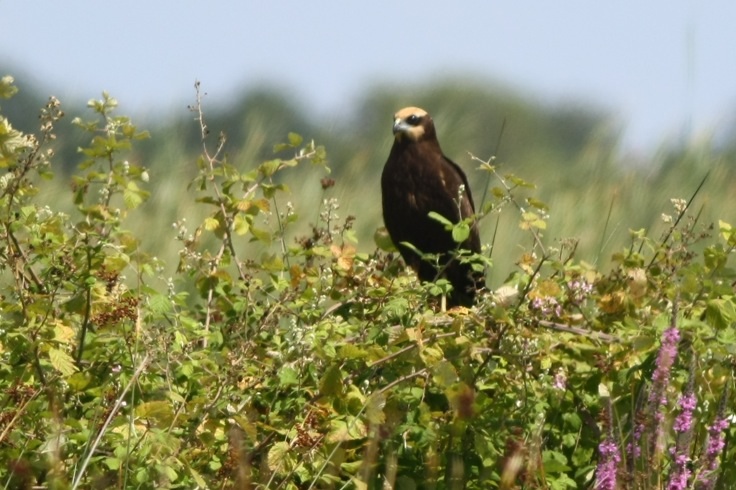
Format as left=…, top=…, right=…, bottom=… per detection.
left=3, top=78, right=736, bottom=287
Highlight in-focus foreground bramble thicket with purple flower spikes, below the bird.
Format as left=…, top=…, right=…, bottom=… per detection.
left=0, top=77, right=736, bottom=489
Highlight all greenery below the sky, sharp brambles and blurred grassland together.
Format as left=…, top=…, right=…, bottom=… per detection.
left=0, top=77, right=736, bottom=489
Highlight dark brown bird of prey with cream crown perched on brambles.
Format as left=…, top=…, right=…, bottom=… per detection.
left=381, top=107, right=485, bottom=306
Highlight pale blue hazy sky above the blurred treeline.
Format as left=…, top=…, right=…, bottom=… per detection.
left=0, top=0, right=736, bottom=150
